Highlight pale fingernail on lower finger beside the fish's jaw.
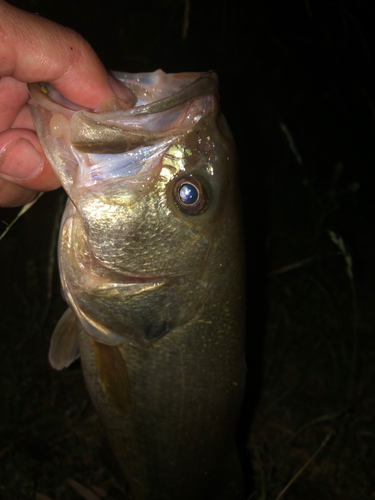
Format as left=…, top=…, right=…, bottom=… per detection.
left=0, top=138, right=43, bottom=180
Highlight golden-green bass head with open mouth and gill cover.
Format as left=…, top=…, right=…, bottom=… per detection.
left=30, top=70, right=238, bottom=347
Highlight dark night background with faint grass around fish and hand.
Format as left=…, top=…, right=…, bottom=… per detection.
left=0, top=0, right=375, bottom=500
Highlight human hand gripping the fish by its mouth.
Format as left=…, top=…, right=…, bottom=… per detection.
left=0, top=0, right=130, bottom=207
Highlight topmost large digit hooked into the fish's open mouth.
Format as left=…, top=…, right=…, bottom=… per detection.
left=0, top=1, right=133, bottom=109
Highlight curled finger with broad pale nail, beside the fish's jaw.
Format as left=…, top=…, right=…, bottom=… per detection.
left=0, top=129, right=60, bottom=191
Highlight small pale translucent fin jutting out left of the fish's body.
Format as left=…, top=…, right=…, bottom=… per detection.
left=48, top=309, right=79, bottom=370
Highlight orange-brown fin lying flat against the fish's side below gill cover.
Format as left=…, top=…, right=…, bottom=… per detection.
left=91, top=338, right=130, bottom=414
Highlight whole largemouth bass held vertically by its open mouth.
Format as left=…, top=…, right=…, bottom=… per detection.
left=29, top=70, right=246, bottom=500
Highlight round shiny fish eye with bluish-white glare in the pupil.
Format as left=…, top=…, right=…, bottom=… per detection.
left=174, top=176, right=208, bottom=215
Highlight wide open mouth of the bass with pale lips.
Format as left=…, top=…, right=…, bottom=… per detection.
left=29, top=71, right=219, bottom=157
